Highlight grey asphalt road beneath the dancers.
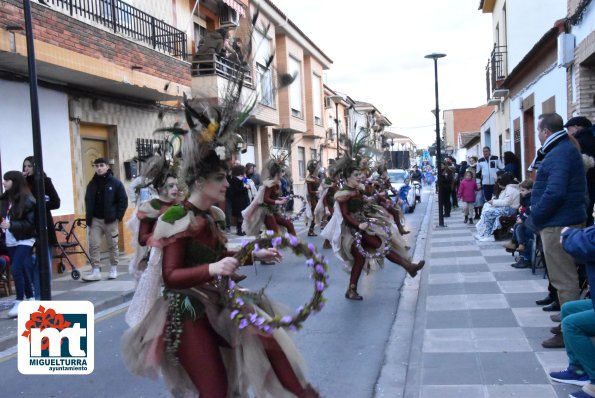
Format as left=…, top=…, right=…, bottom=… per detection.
left=0, top=191, right=429, bottom=398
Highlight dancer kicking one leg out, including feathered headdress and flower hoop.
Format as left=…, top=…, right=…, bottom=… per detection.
left=322, top=141, right=425, bottom=300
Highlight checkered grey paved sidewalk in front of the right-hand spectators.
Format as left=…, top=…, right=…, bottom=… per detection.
left=404, top=199, right=578, bottom=398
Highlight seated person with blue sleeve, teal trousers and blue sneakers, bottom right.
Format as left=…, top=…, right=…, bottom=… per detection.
left=549, top=218, right=595, bottom=398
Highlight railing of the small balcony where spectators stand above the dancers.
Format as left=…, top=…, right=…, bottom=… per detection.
left=191, top=54, right=254, bottom=88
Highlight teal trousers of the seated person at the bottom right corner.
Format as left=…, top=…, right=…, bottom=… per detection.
left=561, top=300, right=595, bottom=382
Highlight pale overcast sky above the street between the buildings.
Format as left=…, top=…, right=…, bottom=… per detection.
left=272, top=0, right=493, bottom=147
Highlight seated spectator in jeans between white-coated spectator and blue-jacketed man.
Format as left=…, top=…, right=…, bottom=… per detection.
left=504, top=178, right=534, bottom=268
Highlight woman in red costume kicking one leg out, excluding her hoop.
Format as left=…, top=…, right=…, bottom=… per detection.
left=322, top=159, right=425, bottom=300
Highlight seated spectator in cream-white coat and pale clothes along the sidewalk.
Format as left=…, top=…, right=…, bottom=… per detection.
left=475, top=173, right=520, bottom=242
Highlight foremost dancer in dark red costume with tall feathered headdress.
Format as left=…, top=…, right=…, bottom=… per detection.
left=122, top=95, right=318, bottom=398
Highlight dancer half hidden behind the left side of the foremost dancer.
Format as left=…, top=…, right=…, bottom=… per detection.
left=125, top=155, right=180, bottom=326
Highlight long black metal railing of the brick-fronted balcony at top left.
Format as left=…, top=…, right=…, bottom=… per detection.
left=45, top=0, right=186, bottom=59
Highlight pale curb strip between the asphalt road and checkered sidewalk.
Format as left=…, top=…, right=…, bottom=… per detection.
left=374, top=189, right=435, bottom=398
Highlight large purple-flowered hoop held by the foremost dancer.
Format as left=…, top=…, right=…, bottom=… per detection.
left=220, top=231, right=329, bottom=334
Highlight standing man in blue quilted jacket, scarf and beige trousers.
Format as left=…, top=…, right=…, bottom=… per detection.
left=529, top=113, right=587, bottom=348
